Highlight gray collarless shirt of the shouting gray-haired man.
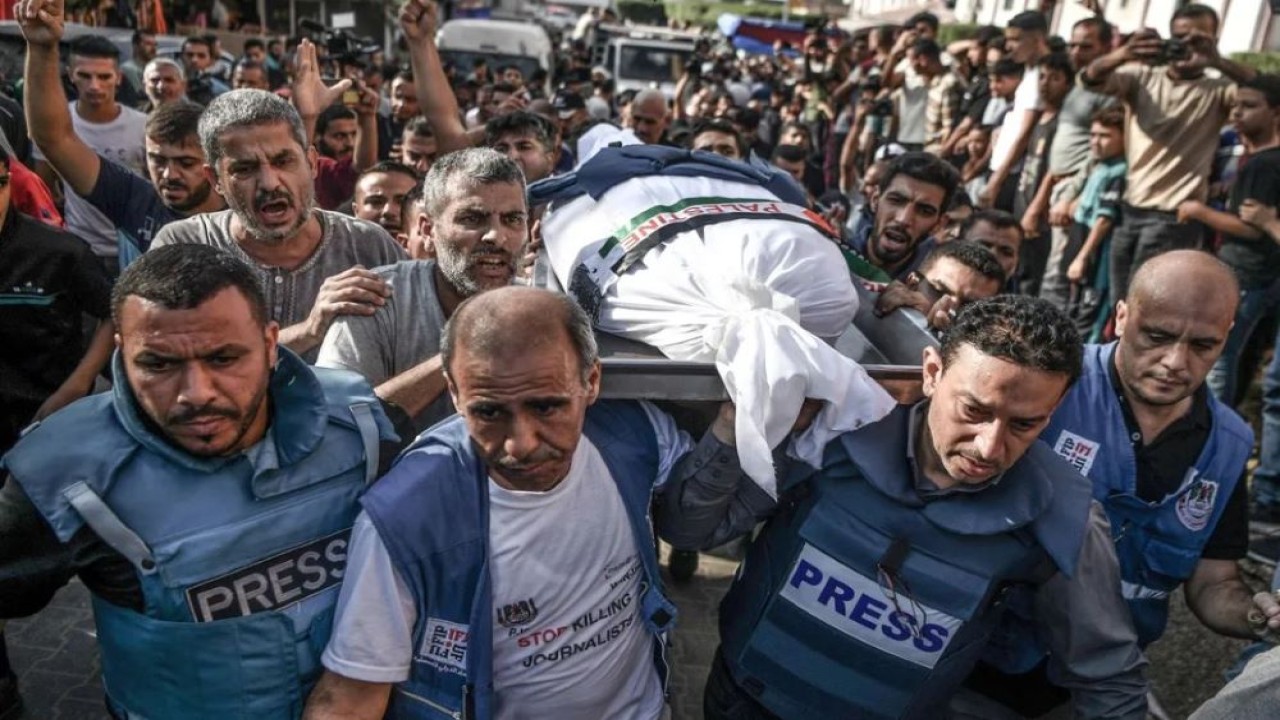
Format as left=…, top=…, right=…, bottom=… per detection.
left=151, top=210, right=404, bottom=363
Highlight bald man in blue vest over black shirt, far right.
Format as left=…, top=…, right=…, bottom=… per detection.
left=967, top=250, right=1280, bottom=715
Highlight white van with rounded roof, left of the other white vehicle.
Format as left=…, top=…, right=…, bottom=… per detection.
left=435, top=19, right=556, bottom=91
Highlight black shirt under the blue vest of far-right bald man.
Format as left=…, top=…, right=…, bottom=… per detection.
left=1107, top=354, right=1249, bottom=560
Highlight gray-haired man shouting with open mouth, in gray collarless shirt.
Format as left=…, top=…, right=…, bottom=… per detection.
left=152, top=87, right=404, bottom=363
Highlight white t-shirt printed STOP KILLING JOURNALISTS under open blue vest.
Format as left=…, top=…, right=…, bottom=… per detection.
left=323, top=404, right=692, bottom=720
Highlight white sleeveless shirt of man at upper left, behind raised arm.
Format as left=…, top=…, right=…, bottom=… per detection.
left=32, top=102, right=147, bottom=258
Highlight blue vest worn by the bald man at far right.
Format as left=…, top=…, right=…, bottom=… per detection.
left=1041, top=343, right=1253, bottom=647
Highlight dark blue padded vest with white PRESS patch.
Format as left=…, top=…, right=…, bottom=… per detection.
left=719, top=407, right=1091, bottom=720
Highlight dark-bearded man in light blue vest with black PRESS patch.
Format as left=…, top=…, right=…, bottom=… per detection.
left=0, top=245, right=407, bottom=720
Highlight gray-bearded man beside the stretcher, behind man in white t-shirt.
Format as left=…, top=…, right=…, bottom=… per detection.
left=316, top=147, right=529, bottom=430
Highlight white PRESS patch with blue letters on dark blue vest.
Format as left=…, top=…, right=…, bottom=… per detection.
left=780, top=543, right=964, bottom=667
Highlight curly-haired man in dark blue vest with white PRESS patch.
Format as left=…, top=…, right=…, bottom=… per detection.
left=704, top=295, right=1147, bottom=720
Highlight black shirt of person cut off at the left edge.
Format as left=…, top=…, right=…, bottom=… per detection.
left=0, top=209, right=111, bottom=450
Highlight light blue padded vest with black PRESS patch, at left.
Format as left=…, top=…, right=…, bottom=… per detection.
left=4, top=347, right=396, bottom=720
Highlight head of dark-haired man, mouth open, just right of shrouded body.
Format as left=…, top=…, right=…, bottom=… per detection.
left=850, top=152, right=960, bottom=282
